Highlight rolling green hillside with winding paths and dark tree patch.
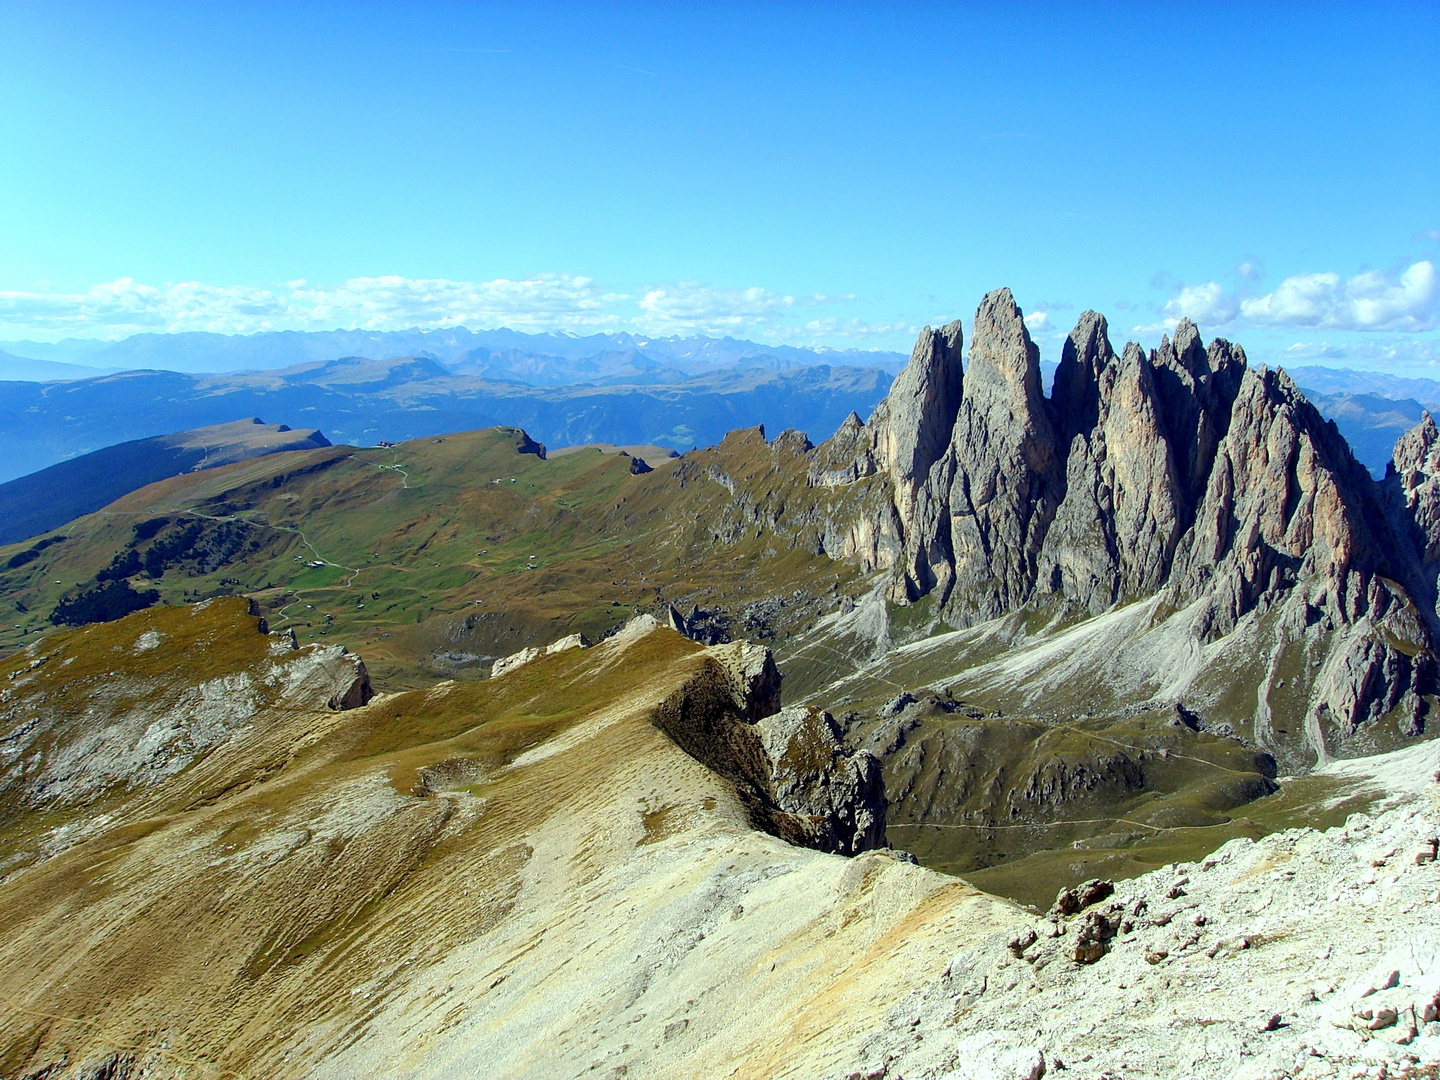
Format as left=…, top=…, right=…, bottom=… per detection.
left=0, top=428, right=857, bottom=685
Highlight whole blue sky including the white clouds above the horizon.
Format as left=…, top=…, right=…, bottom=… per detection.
left=0, top=3, right=1440, bottom=373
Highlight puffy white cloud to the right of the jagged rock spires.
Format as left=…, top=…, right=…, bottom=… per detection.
left=1240, top=261, right=1440, bottom=331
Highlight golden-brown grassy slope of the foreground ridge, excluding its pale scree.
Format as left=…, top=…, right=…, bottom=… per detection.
left=0, top=602, right=708, bottom=1074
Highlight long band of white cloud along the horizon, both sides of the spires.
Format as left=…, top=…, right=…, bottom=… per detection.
left=0, top=259, right=1440, bottom=364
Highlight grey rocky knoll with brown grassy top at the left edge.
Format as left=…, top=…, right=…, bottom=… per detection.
left=0, top=598, right=373, bottom=855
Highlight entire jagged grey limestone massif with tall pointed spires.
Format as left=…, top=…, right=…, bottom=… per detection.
left=812, top=289, right=1440, bottom=757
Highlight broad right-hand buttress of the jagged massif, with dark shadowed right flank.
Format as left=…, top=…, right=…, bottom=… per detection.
left=1172, top=367, right=1434, bottom=757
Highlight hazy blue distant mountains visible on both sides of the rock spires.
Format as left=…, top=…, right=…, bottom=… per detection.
left=0, top=327, right=1440, bottom=481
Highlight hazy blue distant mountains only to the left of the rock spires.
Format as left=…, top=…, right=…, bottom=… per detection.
left=0, top=356, right=891, bottom=481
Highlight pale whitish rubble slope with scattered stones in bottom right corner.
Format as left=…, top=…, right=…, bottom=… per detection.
left=848, top=743, right=1440, bottom=1080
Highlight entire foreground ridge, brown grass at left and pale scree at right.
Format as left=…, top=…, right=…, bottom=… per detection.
left=0, top=600, right=1011, bottom=1077
